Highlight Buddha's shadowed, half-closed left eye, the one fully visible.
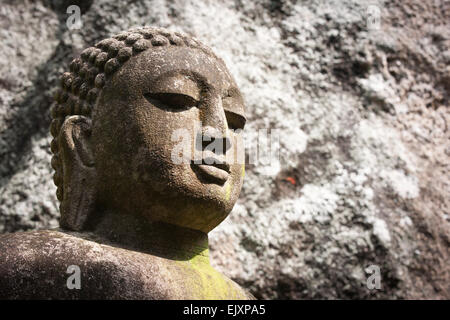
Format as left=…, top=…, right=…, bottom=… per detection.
left=144, top=92, right=198, bottom=112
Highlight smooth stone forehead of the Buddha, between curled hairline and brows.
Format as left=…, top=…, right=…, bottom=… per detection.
left=104, top=46, right=245, bottom=117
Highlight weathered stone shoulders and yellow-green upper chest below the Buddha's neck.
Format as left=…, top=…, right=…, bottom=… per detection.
left=0, top=230, right=252, bottom=299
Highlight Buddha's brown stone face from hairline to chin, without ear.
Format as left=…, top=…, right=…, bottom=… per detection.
left=91, top=46, right=245, bottom=232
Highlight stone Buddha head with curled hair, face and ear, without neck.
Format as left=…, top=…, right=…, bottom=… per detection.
left=51, top=27, right=245, bottom=233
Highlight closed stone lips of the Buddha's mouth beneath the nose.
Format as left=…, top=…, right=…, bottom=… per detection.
left=191, top=158, right=230, bottom=185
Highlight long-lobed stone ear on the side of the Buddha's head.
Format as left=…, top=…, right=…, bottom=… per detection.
left=58, top=116, right=96, bottom=231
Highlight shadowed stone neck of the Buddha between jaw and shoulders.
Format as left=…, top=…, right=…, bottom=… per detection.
left=82, top=211, right=209, bottom=263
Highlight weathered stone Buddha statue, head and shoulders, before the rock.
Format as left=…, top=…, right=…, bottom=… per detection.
left=0, top=27, right=253, bottom=299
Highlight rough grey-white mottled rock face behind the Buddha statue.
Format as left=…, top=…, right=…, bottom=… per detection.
left=0, top=0, right=450, bottom=299
